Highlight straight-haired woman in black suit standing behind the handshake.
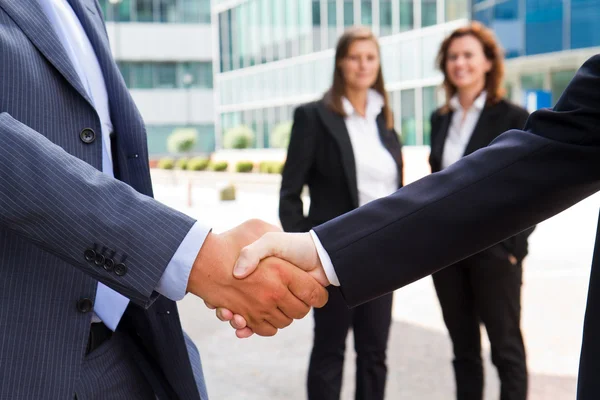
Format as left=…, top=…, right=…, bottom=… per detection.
left=279, top=27, right=402, bottom=400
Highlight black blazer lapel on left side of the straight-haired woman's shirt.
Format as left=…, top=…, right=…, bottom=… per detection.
left=317, top=102, right=358, bottom=207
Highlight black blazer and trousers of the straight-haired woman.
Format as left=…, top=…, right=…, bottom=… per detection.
left=279, top=100, right=402, bottom=400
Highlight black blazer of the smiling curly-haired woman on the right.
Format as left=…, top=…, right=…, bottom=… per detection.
left=429, top=100, right=535, bottom=262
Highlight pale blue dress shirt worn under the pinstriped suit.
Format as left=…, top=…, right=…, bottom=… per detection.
left=39, top=0, right=209, bottom=331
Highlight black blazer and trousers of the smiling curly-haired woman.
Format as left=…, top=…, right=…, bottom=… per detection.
left=429, top=100, right=532, bottom=400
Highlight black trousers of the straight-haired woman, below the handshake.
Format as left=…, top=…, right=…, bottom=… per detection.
left=308, top=286, right=393, bottom=400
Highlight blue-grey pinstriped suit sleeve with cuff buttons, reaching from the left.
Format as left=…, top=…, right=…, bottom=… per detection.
left=0, top=113, right=195, bottom=307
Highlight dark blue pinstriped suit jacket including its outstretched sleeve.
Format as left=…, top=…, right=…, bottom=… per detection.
left=0, top=0, right=200, bottom=400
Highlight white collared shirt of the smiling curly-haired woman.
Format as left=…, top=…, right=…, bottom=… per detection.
left=442, top=91, right=487, bottom=168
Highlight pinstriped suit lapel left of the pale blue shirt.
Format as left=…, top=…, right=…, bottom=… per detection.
left=0, top=0, right=92, bottom=105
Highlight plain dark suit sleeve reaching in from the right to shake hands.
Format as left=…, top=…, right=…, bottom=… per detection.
left=314, top=56, right=600, bottom=306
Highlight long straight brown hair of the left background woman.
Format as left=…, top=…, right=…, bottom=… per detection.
left=323, top=26, right=394, bottom=129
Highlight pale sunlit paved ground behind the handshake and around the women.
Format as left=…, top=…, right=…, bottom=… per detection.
left=155, top=175, right=600, bottom=400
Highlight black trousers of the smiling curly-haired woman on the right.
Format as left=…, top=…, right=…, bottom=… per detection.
left=433, top=252, right=527, bottom=400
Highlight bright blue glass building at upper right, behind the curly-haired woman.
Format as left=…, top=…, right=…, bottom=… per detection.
left=472, top=0, right=600, bottom=111
